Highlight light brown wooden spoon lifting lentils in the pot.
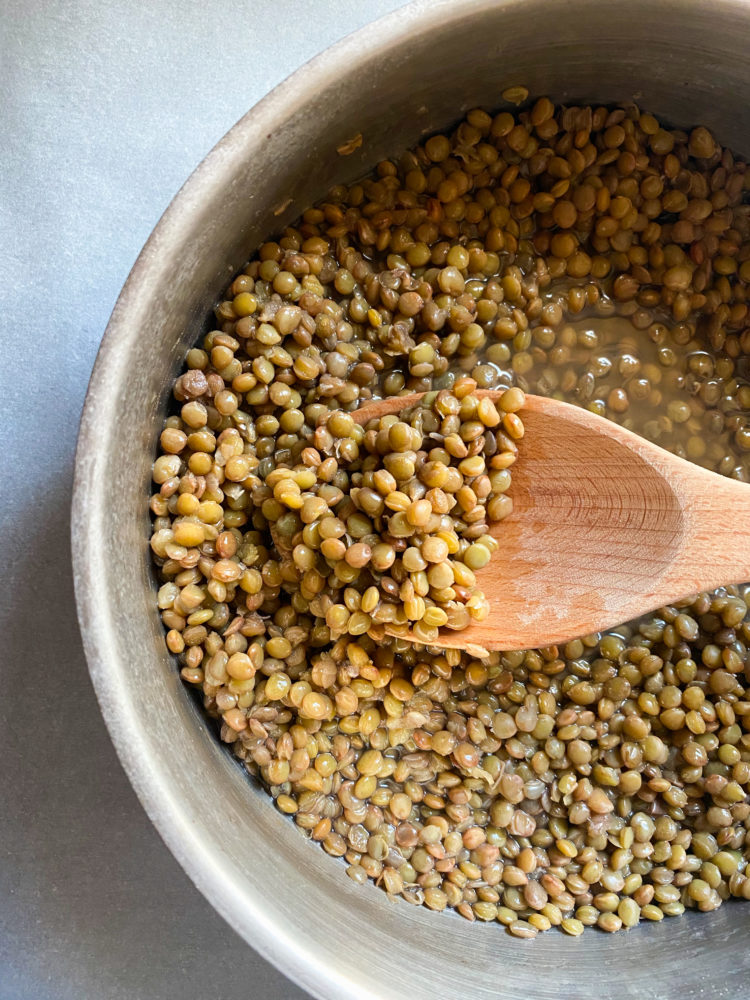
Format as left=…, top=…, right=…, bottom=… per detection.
left=353, top=390, right=750, bottom=650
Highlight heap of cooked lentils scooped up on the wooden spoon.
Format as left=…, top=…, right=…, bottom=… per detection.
left=316, top=377, right=524, bottom=655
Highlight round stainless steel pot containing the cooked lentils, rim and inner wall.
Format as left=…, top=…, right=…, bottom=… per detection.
left=73, top=0, right=750, bottom=1000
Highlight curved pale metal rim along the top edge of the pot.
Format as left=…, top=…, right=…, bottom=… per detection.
left=71, top=0, right=750, bottom=1000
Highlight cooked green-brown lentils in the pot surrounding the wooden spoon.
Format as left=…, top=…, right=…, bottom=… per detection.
left=151, top=95, right=750, bottom=938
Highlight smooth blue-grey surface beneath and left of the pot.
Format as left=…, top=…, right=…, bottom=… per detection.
left=0, top=0, right=401, bottom=1000
